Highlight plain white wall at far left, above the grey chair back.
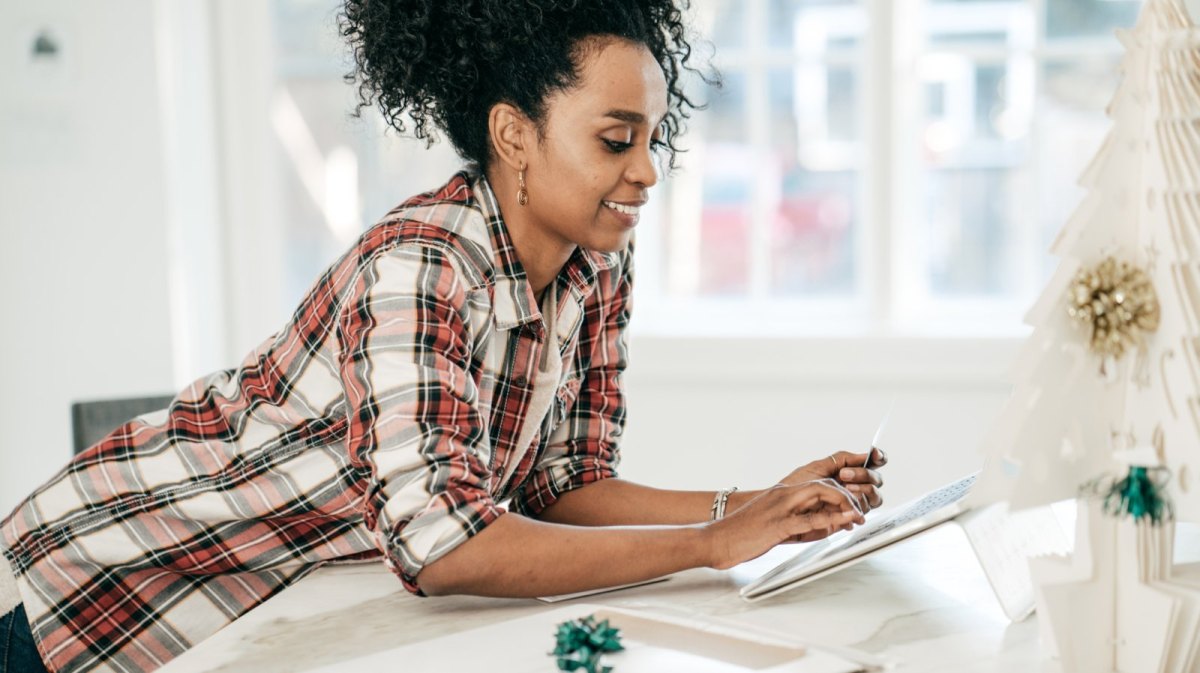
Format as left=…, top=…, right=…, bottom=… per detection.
left=0, top=0, right=172, bottom=512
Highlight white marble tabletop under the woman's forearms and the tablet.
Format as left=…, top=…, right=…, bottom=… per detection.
left=154, top=525, right=1084, bottom=673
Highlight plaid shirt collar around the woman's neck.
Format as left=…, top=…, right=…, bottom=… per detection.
left=466, top=164, right=618, bottom=329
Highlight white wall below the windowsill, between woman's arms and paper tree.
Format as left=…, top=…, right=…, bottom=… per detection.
left=622, top=338, right=1019, bottom=504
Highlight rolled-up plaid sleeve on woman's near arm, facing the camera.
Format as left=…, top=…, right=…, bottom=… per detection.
left=338, top=244, right=503, bottom=595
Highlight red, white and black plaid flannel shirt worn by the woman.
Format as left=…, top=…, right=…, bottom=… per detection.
left=0, top=170, right=631, bottom=672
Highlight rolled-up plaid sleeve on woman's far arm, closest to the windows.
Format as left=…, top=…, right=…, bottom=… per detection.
left=511, top=247, right=634, bottom=517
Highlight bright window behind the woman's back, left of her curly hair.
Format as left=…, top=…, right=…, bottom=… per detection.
left=271, top=0, right=461, bottom=306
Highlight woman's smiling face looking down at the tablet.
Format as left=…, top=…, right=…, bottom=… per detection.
left=526, top=40, right=667, bottom=252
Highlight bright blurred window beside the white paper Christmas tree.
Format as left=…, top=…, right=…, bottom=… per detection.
left=894, top=0, right=1140, bottom=322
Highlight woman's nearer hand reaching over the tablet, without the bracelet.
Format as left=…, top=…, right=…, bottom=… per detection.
left=704, top=479, right=865, bottom=570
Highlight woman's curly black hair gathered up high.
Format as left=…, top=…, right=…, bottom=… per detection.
left=338, top=0, right=719, bottom=168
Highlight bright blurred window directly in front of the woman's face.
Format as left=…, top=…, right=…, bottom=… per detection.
left=638, top=0, right=870, bottom=334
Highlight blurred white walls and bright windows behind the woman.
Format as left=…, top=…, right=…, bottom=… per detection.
left=0, top=0, right=1166, bottom=511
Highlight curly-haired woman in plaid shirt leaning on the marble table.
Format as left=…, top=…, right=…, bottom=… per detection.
left=0, top=0, right=884, bottom=672
